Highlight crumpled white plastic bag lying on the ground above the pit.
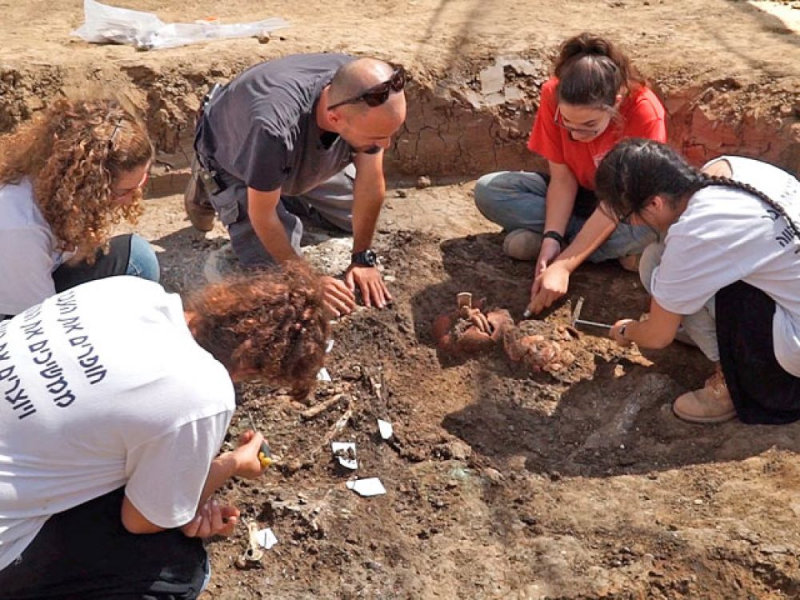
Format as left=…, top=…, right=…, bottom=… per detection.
left=72, top=0, right=289, bottom=50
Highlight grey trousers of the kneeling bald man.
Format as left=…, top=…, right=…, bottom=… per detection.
left=209, top=164, right=355, bottom=267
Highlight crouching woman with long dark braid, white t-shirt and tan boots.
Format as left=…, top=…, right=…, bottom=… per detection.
left=596, top=139, right=800, bottom=423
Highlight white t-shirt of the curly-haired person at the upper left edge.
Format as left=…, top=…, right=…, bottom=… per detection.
left=0, top=178, right=67, bottom=315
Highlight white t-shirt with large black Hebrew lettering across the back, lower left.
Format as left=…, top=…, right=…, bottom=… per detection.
left=0, top=277, right=234, bottom=569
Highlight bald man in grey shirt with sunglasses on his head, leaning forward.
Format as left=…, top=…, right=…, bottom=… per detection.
left=185, top=54, right=406, bottom=316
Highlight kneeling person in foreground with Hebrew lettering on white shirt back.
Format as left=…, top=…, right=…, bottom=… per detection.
left=0, top=265, right=328, bottom=598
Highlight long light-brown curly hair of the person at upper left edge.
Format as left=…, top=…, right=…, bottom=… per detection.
left=0, top=99, right=153, bottom=262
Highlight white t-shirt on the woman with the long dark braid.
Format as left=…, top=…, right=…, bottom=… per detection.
left=651, top=156, right=800, bottom=377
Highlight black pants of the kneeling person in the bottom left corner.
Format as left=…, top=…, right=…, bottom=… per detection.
left=0, top=488, right=206, bottom=600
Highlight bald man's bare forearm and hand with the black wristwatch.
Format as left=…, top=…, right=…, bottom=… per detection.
left=345, top=150, right=392, bottom=308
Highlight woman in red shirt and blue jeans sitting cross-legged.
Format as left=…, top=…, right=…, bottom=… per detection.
left=475, top=33, right=667, bottom=313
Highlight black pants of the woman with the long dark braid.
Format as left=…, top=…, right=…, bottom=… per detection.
left=714, top=281, right=800, bottom=424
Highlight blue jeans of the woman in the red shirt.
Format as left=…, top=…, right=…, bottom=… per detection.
left=475, top=171, right=657, bottom=262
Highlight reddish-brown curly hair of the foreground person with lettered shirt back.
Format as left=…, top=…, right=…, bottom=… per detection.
left=185, top=261, right=330, bottom=397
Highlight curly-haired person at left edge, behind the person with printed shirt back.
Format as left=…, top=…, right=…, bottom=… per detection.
left=0, top=99, right=159, bottom=320
